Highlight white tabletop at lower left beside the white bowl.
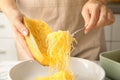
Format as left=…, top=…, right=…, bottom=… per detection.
left=0, top=61, right=111, bottom=80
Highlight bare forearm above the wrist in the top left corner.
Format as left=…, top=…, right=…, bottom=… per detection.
left=0, top=0, right=17, bottom=14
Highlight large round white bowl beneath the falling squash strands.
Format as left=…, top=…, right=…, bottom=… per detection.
left=9, top=57, right=105, bottom=80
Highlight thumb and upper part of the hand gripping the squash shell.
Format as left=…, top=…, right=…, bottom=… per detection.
left=6, top=9, right=28, bottom=36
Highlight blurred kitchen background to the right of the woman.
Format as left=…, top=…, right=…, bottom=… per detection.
left=104, top=0, right=120, bottom=51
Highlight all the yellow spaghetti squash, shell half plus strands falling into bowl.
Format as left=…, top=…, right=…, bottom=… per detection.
left=24, top=17, right=74, bottom=80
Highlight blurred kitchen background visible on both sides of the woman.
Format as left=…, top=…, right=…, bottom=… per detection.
left=0, top=0, right=120, bottom=61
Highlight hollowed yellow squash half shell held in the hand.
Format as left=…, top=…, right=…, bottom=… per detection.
left=24, top=17, right=52, bottom=66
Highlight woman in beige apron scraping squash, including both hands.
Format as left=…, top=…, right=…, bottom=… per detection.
left=0, top=0, right=114, bottom=60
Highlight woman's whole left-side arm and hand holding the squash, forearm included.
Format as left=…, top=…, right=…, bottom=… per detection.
left=0, top=0, right=33, bottom=60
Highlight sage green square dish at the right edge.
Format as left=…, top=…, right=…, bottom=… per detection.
left=100, top=50, right=120, bottom=80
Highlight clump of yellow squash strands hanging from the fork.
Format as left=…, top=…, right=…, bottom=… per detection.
left=47, top=31, right=73, bottom=70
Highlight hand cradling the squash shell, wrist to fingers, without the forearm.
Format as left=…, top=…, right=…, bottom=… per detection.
left=6, top=9, right=33, bottom=60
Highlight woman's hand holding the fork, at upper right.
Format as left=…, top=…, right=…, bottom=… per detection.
left=82, top=0, right=115, bottom=33
